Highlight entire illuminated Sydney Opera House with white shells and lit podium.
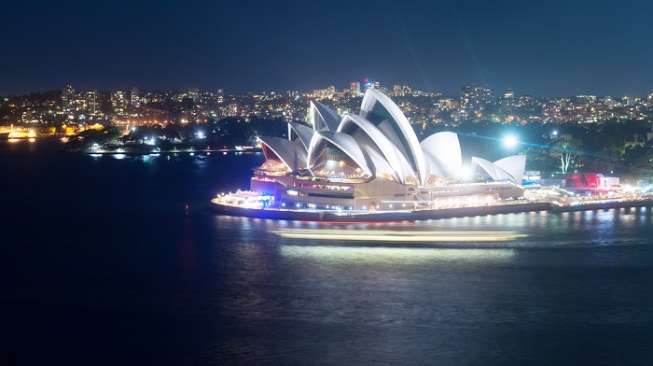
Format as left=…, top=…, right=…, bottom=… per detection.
left=216, top=89, right=526, bottom=212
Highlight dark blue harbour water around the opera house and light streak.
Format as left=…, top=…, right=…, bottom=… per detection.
left=0, top=139, right=653, bottom=365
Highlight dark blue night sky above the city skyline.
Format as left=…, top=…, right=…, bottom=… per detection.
left=0, top=0, right=653, bottom=96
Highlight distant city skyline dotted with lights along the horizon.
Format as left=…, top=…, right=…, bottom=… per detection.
left=5, top=80, right=653, bottom=129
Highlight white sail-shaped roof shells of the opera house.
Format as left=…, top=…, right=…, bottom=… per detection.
left=260, top=88, right=526, bottom=186
